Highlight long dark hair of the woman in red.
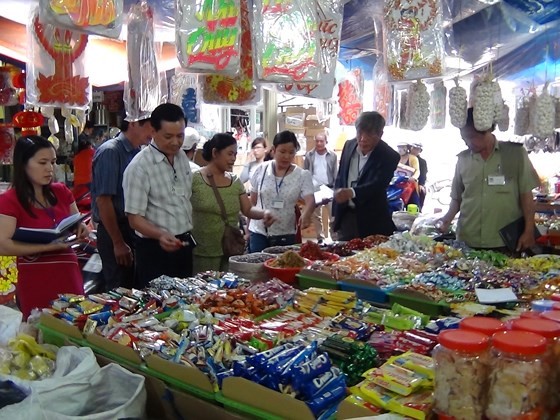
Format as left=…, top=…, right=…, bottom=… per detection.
left=12, top=136, right=57, bottom=217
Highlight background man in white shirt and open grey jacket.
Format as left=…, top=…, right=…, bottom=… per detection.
left=303, top=133, right=338, bottom=241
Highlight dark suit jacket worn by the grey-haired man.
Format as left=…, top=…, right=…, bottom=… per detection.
left=333, top=139, right=400, bottom=238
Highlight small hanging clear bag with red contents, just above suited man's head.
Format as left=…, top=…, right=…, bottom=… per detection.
left=338, top=69, right=364, bottom=125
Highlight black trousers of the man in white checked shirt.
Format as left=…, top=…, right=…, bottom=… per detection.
left=134, top=235, right=193, bottom=289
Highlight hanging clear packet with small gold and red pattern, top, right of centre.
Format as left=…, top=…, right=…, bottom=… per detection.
left=384, top=0, right=445, bottom=81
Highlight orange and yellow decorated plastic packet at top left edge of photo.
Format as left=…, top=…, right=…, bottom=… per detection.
left=39, top=0, right=123, bottom=38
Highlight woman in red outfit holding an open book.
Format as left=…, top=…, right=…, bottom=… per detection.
left=0, top=136, right=88, bottom=319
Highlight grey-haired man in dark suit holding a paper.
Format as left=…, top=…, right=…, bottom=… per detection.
left=333, top=111, right=400, bottom=241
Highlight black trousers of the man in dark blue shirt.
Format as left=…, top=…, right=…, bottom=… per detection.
left=97, top=221, right=137, bottom=291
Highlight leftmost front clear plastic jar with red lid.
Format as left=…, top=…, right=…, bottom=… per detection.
left=432, top=329, right=490, bottom=420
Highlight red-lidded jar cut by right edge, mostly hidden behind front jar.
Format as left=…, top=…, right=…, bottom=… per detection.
left=511, top=318, right=560, bottom=413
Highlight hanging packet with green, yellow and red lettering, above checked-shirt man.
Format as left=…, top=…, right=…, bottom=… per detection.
left=175, top=0, right=242, bottom=76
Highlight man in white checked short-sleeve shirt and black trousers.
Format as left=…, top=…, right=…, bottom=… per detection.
left=123, top=103, right=195, bottom=288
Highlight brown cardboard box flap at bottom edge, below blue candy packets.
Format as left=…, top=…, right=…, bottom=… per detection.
left=222, top=377, right=315, bottom=420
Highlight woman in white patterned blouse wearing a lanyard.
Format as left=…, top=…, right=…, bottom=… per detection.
left=249, top=131, right=315, bottom=252
